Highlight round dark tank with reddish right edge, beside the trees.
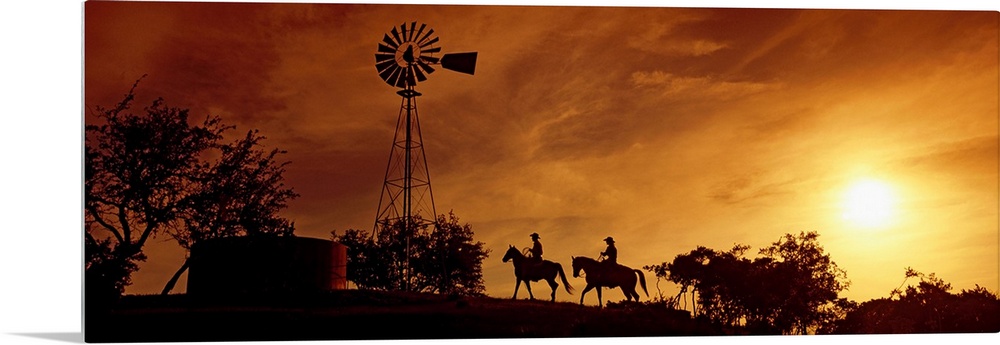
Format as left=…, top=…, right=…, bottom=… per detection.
left=187, top=237, right=347, bottom=295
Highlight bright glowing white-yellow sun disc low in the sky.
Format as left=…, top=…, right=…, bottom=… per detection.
left=843, top=179, right=896, bottom=229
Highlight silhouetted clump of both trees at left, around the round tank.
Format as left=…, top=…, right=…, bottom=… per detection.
left=84, top=79, right=296, bottom=303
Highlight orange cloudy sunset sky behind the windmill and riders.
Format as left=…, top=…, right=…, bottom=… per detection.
left=83, top=2, right=1000, bottom=302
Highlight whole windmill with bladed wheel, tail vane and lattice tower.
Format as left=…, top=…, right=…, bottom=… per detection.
left=372, top=22, right=477, bottom=290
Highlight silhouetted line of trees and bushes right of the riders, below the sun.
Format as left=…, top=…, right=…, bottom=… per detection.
left=643, top=232, right=1000, bottom=334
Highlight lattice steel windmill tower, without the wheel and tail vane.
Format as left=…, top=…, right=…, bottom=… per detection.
left=372, top=87, right=437, bottom=290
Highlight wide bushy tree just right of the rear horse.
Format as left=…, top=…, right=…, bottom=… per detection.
left=646, top=232, right=849, bottom=334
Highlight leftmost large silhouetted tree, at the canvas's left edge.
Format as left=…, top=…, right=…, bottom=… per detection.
left=84, top=81, right=226, bottom=295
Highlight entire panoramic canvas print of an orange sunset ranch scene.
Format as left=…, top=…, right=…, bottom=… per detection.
left=82, top=1, right=1000, bottom=342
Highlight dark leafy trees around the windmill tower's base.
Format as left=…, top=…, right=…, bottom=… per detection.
left=332, top=212, right=489, bottom=296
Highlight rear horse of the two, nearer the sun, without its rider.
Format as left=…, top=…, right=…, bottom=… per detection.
left=572, top=256, right=649, bottom=307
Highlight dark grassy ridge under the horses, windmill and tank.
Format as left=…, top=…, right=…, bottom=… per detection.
left=84, top=290, right=724, bottom=342
